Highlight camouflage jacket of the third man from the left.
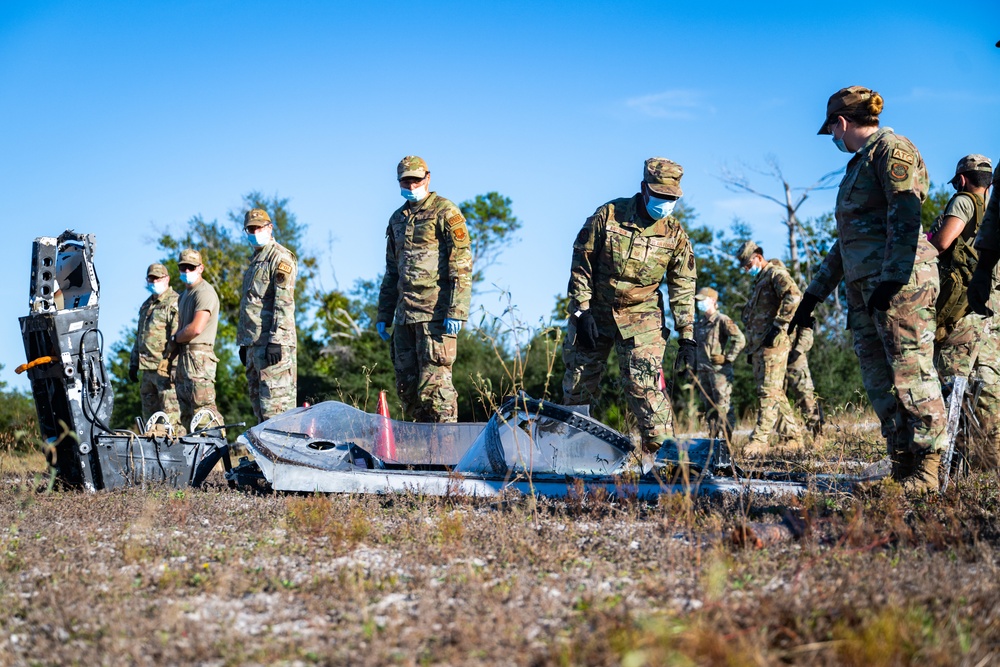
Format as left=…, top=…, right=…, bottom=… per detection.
left=236, top=241, right=296, bottom=346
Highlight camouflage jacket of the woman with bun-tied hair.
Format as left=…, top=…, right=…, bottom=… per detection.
left=806, top=127, right=937, bottom=299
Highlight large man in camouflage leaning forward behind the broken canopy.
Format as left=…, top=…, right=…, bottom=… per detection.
left=563, top=158, right=696, bottom=451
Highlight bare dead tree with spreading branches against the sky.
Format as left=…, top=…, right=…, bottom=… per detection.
left=719, top=155, right=844, bottom=283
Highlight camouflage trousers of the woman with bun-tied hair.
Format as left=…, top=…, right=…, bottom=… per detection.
left=847, top=262, right=947, bottom=456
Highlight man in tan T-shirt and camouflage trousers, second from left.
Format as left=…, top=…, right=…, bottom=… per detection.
left=171, top=248, right=223, bottom=427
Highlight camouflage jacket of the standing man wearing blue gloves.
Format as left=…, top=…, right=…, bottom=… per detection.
left=377, top=192, right=472, bottom=324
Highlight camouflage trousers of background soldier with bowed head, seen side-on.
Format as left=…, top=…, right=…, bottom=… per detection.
left=749, top=332, right=802, bottom=451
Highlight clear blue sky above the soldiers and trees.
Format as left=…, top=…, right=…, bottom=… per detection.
left=0, top=0, right=1000, bottom=388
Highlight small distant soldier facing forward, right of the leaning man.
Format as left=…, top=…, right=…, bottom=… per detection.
left=694, top=287, right=746, bottom=441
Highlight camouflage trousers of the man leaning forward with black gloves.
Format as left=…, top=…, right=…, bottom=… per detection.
left=563, top=320, right=674, bottom=450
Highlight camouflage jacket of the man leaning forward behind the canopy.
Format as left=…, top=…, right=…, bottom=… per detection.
left=567, top=194, right=695, bottom=339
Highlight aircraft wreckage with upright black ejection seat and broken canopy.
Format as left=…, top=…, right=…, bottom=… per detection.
left=18, top=231, right=928, bottom=497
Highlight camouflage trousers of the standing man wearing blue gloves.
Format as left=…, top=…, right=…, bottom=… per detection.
left=392, top=321, right=458, bottom=422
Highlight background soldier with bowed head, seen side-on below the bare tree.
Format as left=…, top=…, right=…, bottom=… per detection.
left=736, top=241, right=802, bottom=454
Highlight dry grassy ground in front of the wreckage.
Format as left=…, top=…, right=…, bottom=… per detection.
left=0, top=418, right=1000, bottom=666
